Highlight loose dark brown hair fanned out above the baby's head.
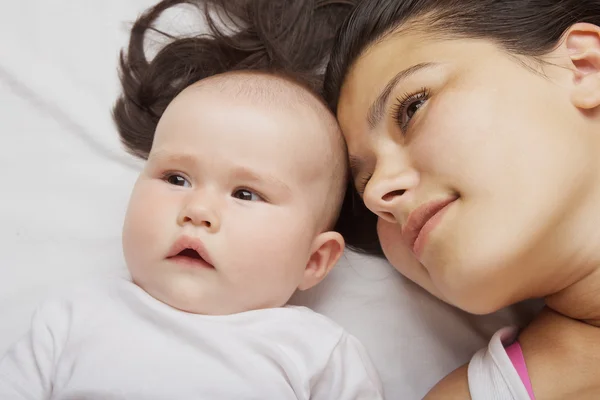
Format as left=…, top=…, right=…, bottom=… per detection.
left=113, top=0, right=357, bottom=159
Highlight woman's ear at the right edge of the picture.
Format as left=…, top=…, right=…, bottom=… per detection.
left=563, top=23, right=600, bottom=110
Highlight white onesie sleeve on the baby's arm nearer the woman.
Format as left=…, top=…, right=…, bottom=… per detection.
left=310, top=333, right=383, bottom=400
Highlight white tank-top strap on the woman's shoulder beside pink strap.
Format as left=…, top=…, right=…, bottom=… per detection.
left=468, top=328, right=530, bottom=400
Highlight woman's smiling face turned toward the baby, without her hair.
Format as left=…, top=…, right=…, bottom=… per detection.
left=338, top=33, right=599, bottom=313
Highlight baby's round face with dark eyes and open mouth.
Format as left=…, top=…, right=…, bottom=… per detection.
left=123, top=76, right=344, bottom=314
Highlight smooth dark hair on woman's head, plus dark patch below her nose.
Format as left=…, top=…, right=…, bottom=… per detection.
left=324, top=0, right=600, bottom=254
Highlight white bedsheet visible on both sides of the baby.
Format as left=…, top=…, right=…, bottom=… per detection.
left=0, top=0, right=540, bottom=399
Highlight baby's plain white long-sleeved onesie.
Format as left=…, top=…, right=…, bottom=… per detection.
left=0, top=280, right=383, bottom=400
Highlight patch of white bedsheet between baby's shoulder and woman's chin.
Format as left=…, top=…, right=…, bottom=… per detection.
left=292, top=251, right=540, bottom=399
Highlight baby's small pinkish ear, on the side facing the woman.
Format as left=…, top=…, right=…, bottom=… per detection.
left=298, top=232, right=344, bottom=290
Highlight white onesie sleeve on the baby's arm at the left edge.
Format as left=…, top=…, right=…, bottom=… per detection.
left=0, top=304, right=65, bottom=400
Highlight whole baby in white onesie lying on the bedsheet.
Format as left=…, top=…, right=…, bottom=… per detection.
left=0, top=72, right=382, bottom=400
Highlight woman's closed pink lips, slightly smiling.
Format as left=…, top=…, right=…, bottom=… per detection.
left=402, top=197, right=457, bottom=257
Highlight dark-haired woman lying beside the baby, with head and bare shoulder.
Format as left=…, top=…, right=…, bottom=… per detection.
left=325, top=0, right=600, bottom=399
